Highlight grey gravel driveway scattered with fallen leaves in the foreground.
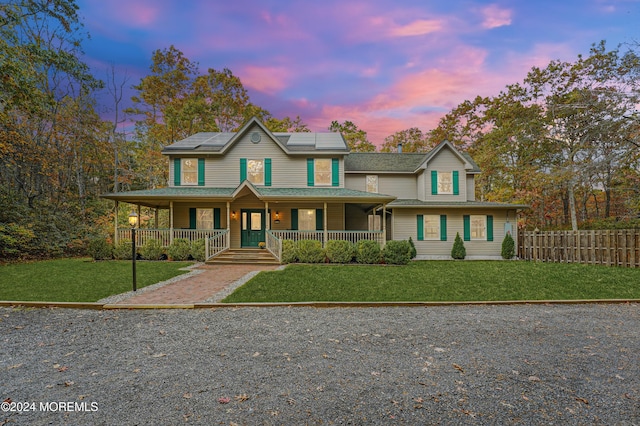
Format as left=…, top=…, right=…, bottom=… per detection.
left=0, top=304, right=640, bottom=425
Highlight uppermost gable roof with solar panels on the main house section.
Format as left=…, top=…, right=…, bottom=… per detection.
left=162, top=117, right=349, bottom=154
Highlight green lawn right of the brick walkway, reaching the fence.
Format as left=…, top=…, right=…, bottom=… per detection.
left=223, top=261, right=640, bottom=303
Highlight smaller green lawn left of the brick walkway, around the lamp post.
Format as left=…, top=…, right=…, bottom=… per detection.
left=0, top=259, right=193, bottom=302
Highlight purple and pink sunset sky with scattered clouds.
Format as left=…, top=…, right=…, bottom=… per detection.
left=77, top=0, right=640, bottom=145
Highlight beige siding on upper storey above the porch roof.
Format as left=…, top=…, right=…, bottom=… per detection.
left=169, top=127, right=344, bottom=188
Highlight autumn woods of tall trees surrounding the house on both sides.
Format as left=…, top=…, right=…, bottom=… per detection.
left=0, top=0, right=640, bottom=260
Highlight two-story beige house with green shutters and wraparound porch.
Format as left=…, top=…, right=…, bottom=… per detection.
left=104, top=119, right=527, bottom=259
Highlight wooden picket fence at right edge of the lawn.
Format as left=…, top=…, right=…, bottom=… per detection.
left=518, top=229, right=640, bottom=268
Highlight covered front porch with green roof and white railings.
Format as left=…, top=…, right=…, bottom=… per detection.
left=104, top=181, right=394, bottom=262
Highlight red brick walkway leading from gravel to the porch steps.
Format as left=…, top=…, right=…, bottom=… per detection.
left=118, top=265, right=279, bottom=305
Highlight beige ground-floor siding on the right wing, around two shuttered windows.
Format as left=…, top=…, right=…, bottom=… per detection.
left=393, top=209, right=517, bottom=258
